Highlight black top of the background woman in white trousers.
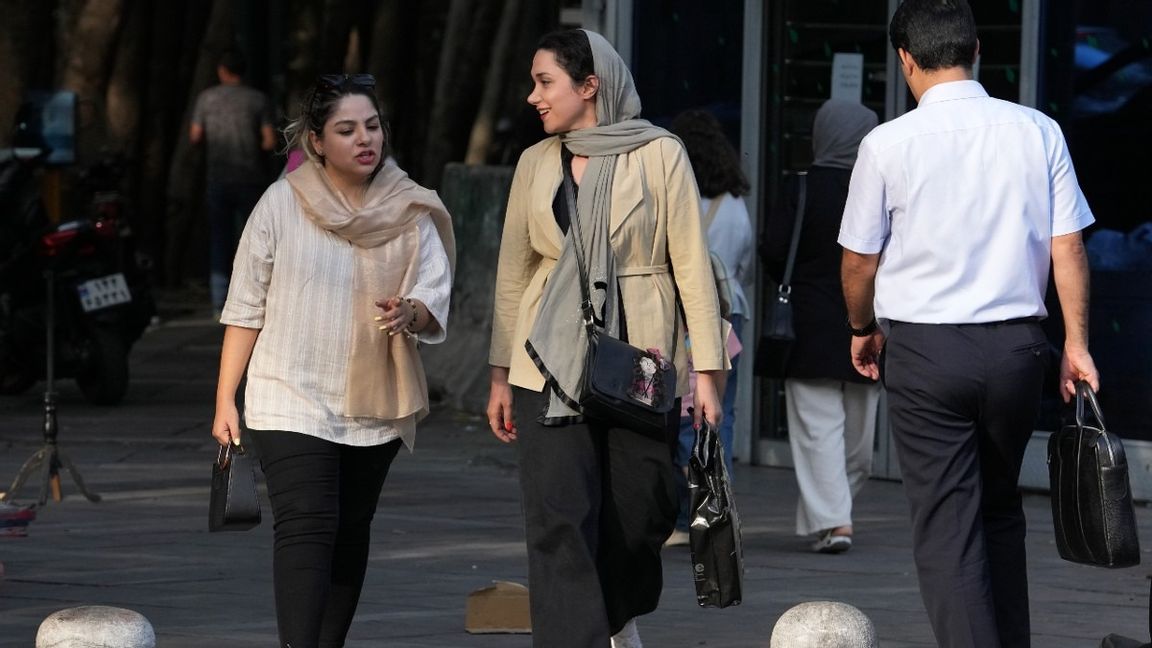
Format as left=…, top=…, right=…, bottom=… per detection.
left=760, top=166, right=871, bottom=383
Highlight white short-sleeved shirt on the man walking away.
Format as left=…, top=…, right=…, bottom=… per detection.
left=839, top=81, right=1094, bottom=324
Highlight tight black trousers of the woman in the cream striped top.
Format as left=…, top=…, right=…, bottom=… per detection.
left=249, top=430, right=401, bottom=648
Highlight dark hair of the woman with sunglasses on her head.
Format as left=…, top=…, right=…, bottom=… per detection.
left=283, top=74, right=392, bottom=165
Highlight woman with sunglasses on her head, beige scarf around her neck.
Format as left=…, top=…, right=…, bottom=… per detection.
left=212, top=75, right=455, bottom=648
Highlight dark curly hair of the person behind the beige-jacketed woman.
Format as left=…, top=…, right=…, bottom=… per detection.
left=672, top=111, right=750, bottom=198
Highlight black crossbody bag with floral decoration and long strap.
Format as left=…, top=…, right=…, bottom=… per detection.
left=564, top=169, right=680, bottom=439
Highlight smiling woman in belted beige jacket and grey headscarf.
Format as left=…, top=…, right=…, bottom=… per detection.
left=487, top=30, right=729, bottom=648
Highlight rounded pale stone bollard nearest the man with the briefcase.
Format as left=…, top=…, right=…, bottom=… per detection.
left=770, top=601, right=879, bottom=648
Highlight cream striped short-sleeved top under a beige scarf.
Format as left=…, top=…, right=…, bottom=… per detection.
left=220, top=180, right=452, bottom=449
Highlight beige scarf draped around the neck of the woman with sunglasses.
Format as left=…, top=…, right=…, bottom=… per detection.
left=287, top=158, right=456, bottom=421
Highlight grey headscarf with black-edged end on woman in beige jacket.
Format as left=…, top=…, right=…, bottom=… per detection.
left=524, top=30, right=674, bottom=424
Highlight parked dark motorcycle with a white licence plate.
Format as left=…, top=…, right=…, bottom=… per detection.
left=0, top=146, right=156, bottom=405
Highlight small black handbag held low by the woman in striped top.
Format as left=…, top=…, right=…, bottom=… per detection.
left=209, top=443, right=260, bottom=532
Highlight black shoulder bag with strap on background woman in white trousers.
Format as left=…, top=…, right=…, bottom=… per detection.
left=755, top=172, right=808, bottom=378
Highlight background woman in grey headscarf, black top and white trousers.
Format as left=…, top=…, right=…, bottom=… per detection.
left=761, top=99, right=880, bottom=553
